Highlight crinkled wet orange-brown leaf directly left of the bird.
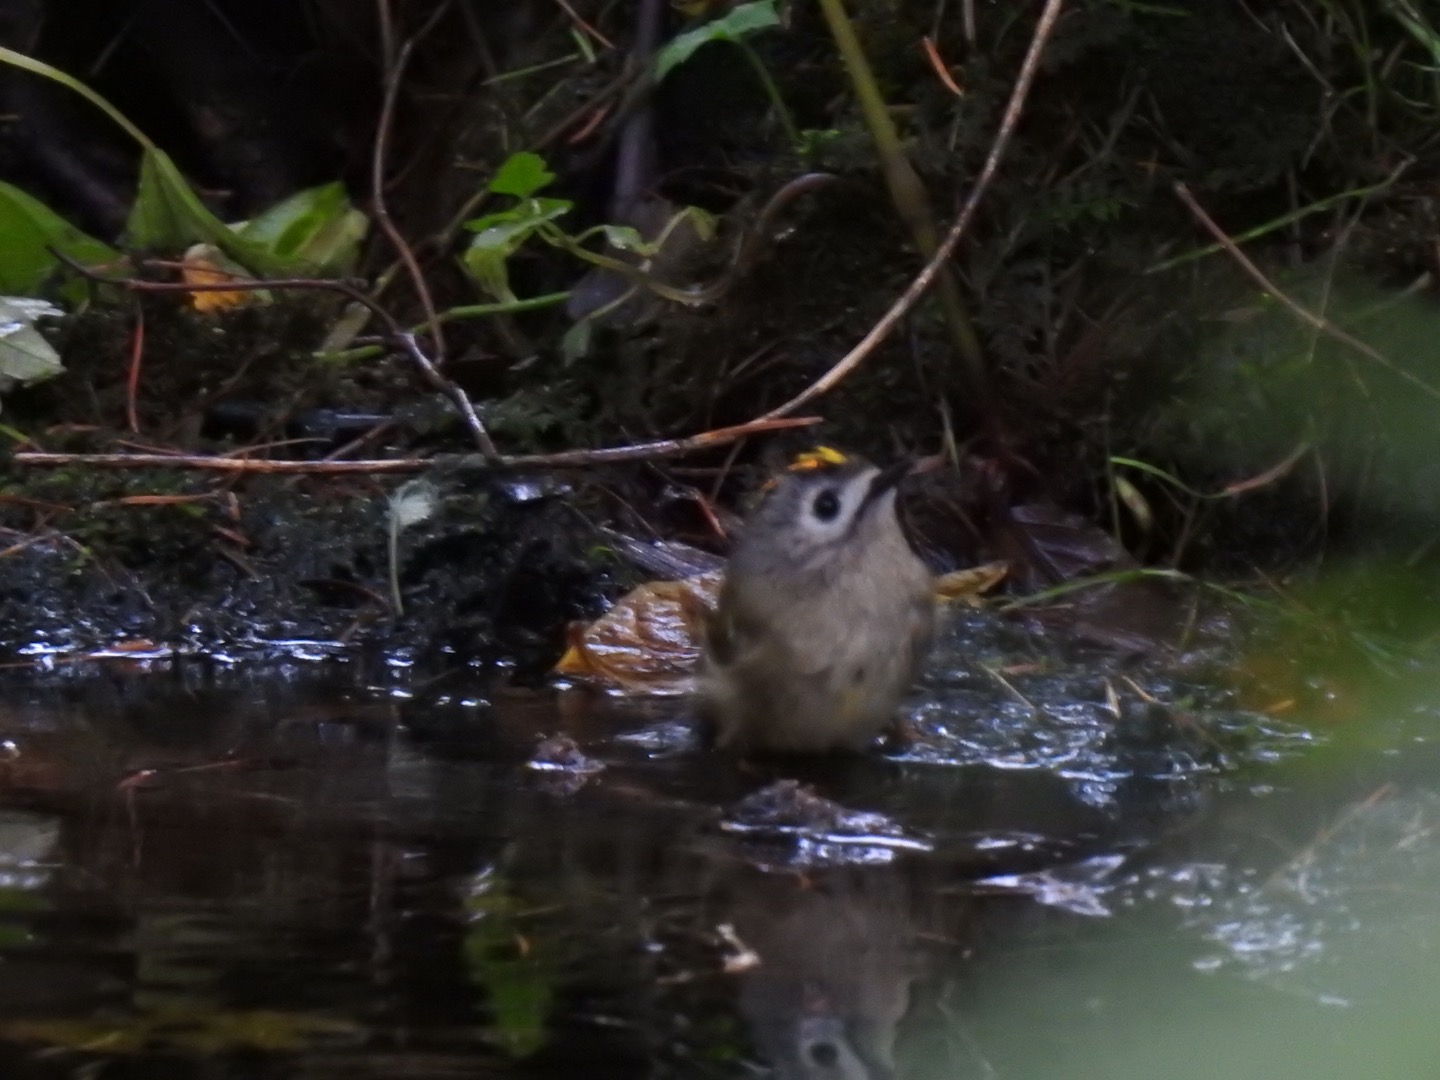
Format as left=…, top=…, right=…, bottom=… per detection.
left=554, top=570, right=723, bottom=694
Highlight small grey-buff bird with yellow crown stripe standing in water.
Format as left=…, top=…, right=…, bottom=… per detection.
left=697, top=446, right=935, bottom=753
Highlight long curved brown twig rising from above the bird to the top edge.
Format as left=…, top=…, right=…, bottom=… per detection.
left=760, top=0, right=1064, bottom=420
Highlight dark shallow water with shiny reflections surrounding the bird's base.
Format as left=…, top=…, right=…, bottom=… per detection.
left=0, top=616, right=1440, bottom=1080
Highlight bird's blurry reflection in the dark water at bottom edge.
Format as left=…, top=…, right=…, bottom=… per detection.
left=733, top=868, right=919, bottom=1080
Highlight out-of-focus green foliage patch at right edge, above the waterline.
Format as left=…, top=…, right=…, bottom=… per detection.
left=1166, top=268, right=1440, bottom=541
